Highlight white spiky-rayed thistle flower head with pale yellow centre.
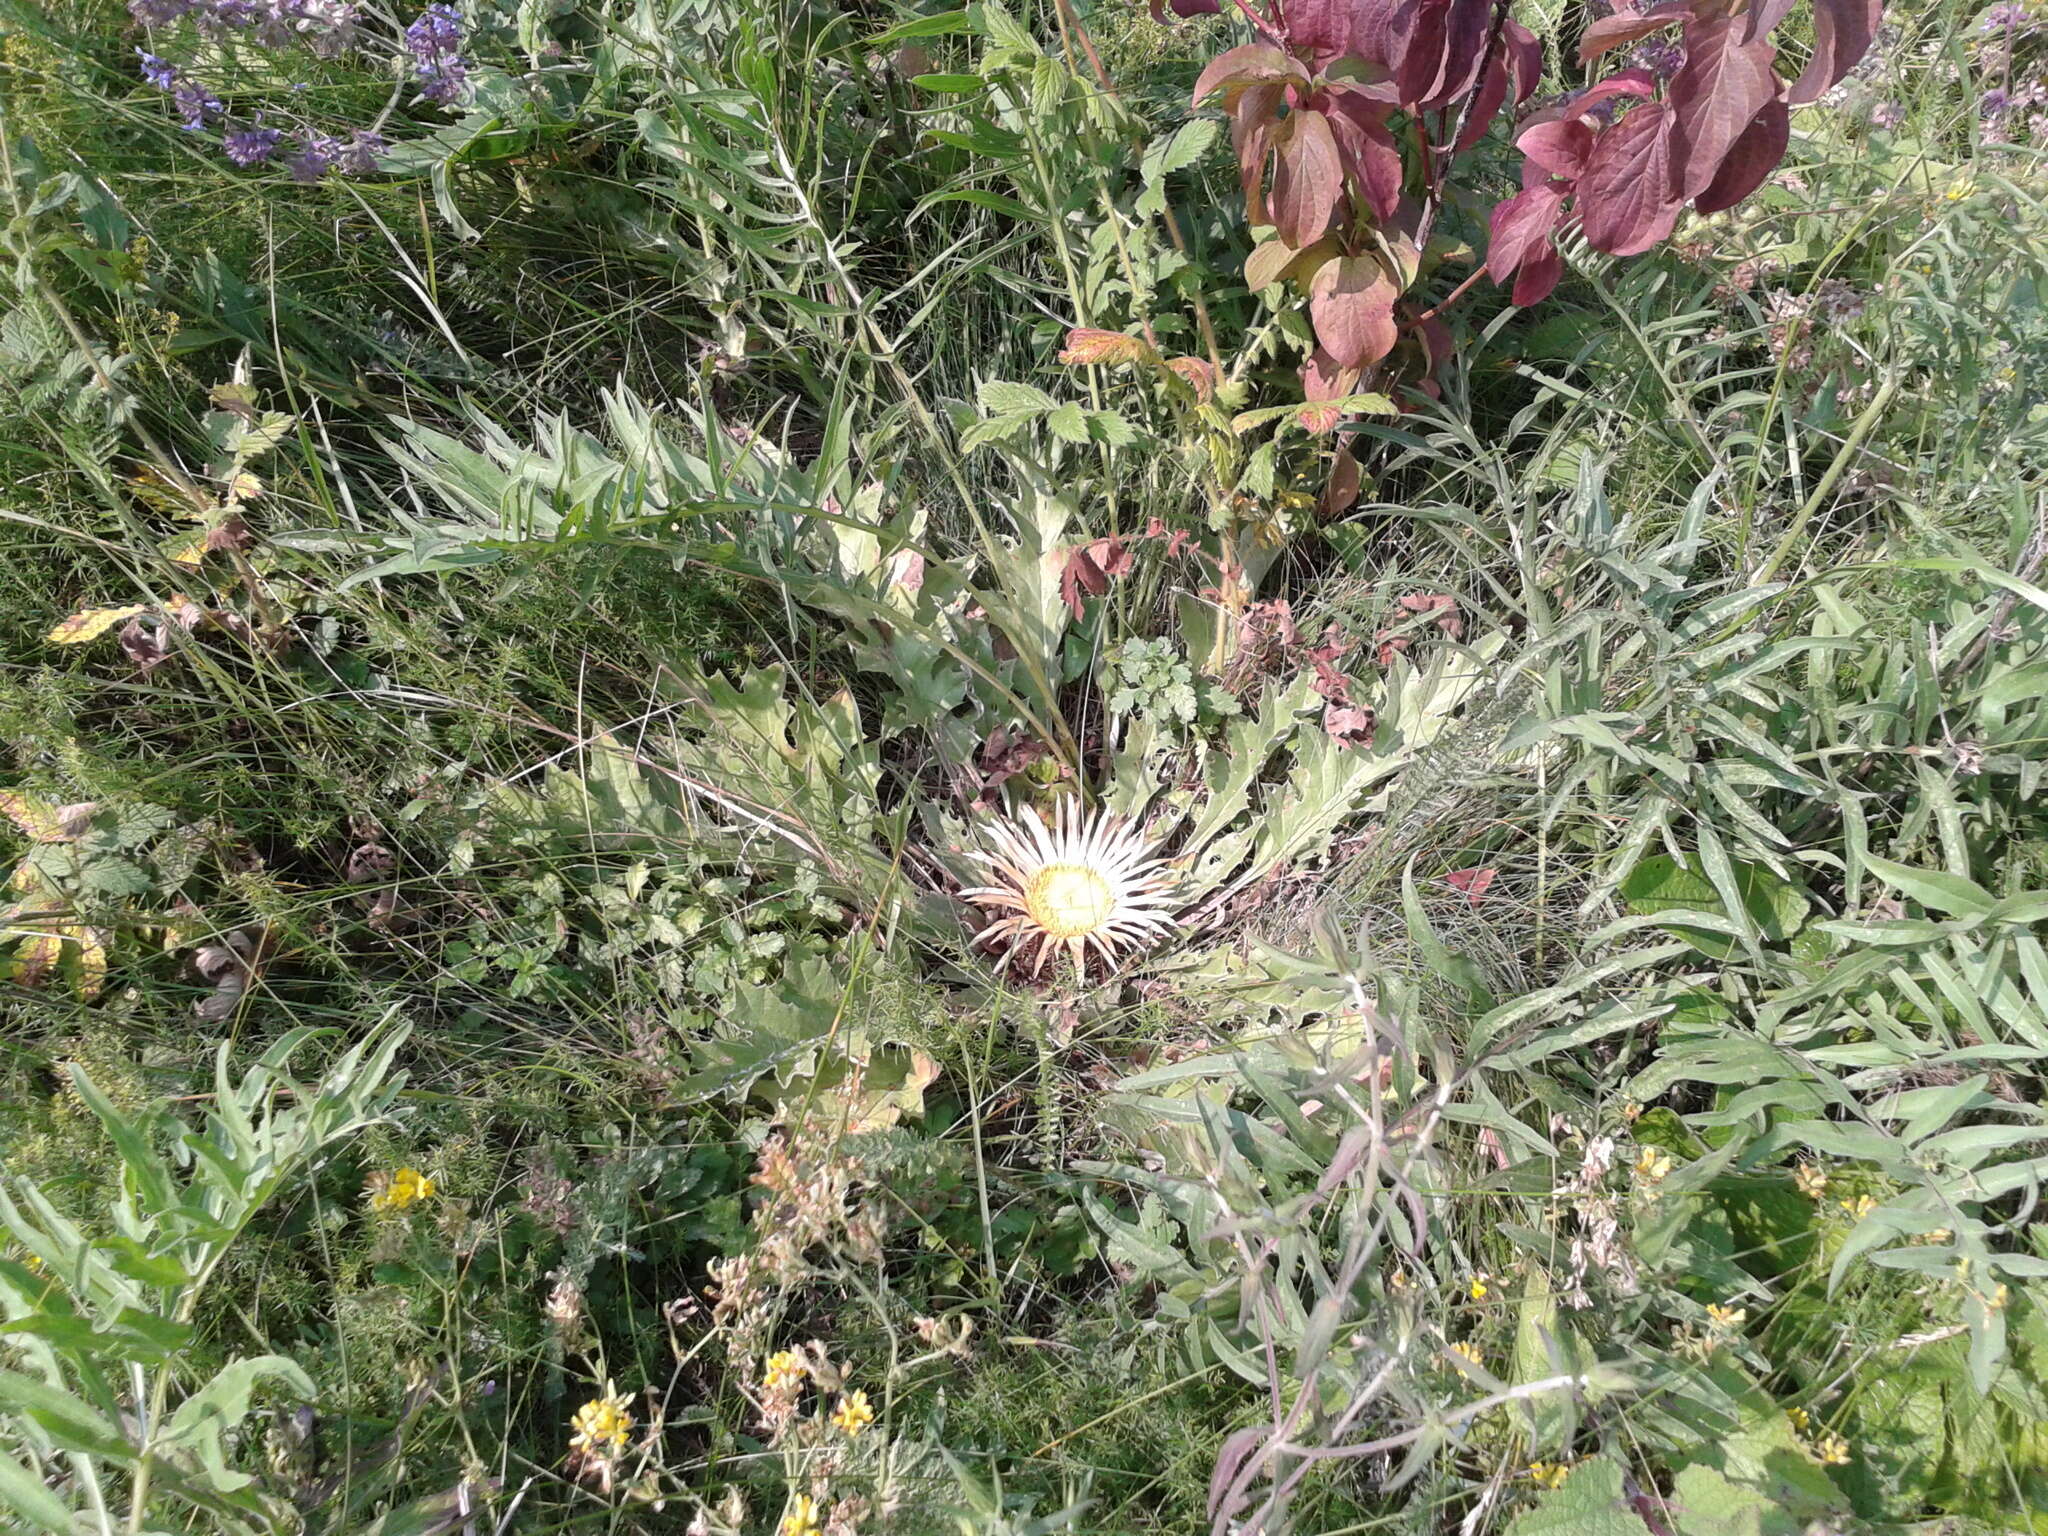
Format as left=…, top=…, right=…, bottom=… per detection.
left=961, top=799, right=1180, bottom=977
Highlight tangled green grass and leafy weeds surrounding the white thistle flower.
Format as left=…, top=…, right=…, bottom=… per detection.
left=0, top=0, right=2048, bottom=1536
